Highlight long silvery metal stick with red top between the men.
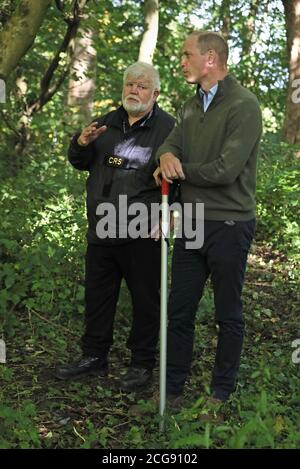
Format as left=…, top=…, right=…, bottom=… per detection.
left=159, top=179, right=170, bottom=432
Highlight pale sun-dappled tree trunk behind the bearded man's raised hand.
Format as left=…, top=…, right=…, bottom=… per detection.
left=68, top=28, right=97, bottom=124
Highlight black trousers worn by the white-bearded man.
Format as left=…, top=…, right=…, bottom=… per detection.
left=82, top=238, right=160, bottom=369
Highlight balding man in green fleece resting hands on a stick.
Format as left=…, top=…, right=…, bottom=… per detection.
left=154, top=31, right=262, bottom=403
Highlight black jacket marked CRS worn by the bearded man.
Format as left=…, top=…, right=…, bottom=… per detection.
left=68, top=104, right=175, bottom=244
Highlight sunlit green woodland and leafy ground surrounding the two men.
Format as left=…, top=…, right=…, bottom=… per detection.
left=0, top=0, right=300, bottom=448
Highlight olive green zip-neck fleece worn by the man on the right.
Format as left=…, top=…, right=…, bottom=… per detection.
left=156, top=75, right=262, bottom=221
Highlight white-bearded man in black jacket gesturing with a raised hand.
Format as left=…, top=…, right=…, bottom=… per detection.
left=55, top=62, right=175, bottom=392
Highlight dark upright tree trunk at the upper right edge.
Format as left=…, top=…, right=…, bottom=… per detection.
left=283, top=0, right=300, bottom=143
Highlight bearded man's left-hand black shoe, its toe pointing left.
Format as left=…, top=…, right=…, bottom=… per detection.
left=54, top=357, right=108, bottom=379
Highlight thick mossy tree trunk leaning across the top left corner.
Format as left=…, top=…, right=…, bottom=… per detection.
left=0, top=0, right=51, bottom=80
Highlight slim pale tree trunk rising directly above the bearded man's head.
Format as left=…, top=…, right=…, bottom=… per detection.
left=139, top=0, right=159, bottom=64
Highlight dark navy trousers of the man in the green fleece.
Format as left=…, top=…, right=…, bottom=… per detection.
left=167, top=220, right=255, bottom=400
